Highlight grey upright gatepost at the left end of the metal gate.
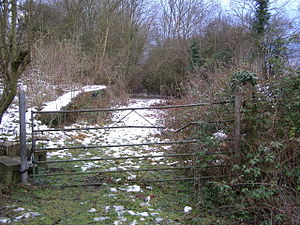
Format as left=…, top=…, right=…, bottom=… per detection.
left=19, top=91, right=28, bottom=184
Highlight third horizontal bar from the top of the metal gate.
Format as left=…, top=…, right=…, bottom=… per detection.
left=35, top=140, right=199, bottom=152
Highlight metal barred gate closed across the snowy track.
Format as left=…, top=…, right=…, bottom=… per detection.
left=31, top=101, right=232, bottom=186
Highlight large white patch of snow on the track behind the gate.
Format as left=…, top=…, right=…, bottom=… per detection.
left=44, top=99, right=169, bottom=171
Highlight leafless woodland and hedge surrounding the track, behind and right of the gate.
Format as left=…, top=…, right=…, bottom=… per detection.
left=0, top=0, right=300, bottom=225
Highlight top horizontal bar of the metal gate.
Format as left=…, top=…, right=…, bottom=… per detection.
left=33, top=101, right=233, bottom=114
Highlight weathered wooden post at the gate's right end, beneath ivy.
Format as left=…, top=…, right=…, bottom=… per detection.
left=234, top=88, right=242, bottom=163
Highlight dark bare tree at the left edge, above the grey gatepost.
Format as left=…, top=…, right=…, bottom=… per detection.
left=0, top=0, right=32, bottom=124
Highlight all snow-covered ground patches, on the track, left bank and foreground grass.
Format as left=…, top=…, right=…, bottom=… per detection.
left=0, top=86, right=192, bottom=225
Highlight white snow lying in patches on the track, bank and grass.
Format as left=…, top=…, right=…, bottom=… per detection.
left=0, top=86, right=192, bottom=224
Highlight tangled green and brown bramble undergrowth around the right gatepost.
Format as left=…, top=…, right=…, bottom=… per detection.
left=167, top=71, right=300, bottom=225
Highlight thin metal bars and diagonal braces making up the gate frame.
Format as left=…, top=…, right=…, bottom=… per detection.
left=20, top=95, right=240, bottom=186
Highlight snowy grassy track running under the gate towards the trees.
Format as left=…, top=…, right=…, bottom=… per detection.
left=0, top=92, right=196, bottom=225
